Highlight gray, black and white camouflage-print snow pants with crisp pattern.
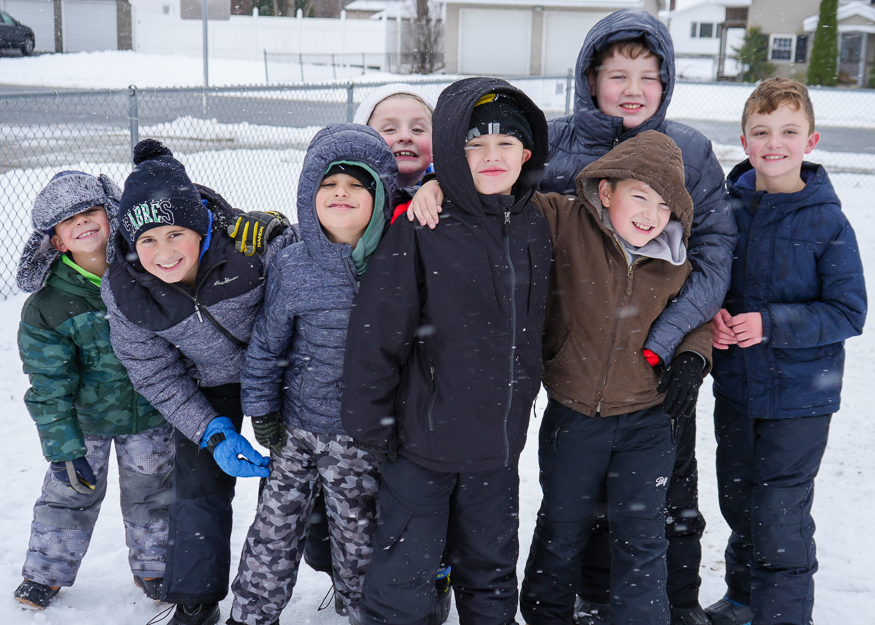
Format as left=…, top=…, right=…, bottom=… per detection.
left=231, top=429, right=379, bottom=625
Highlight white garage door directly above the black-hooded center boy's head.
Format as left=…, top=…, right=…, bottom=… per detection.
left=459, top=9, right=532, bottom=76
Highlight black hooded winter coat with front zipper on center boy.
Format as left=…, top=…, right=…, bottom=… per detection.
left=341, top=78, right=552, bottom=472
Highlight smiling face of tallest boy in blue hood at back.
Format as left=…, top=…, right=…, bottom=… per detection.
left=589, top=54, right=662, bottom=129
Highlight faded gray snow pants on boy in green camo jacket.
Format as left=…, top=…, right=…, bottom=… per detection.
left=21, top=423, right=174, bottom=586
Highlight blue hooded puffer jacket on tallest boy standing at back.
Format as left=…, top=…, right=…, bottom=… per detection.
left=540, top=9, right=737, bottom=363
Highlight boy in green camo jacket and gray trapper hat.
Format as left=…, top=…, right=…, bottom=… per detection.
left=15, top=171, right=174, bottom=609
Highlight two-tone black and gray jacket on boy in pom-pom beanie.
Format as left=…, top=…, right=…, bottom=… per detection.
left=101, top=187, right=299, bottom=443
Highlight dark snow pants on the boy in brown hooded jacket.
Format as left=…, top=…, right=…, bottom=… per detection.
left=520, top=398, right=674, bottom=625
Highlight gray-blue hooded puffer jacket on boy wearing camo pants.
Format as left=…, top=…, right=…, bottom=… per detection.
left=240, top=124, right=398, bottom=434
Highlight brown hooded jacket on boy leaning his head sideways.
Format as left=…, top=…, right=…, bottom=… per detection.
left=535, top=130, right=711, bottom=416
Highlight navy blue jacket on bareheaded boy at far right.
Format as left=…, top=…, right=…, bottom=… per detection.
left=712, top=161, right=866, bottom=419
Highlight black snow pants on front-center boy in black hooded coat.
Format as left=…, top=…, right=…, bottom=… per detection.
left=361, top=457, right=519, bottom=625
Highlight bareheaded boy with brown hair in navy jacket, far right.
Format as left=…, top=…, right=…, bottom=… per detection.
left=707, top=78, right=866, bottom=625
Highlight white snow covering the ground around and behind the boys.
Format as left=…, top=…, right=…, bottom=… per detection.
left=0, top=53, right=875, bottom=625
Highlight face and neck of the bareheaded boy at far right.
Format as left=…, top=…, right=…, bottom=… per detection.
left=741, top=104, right=820, bottom=193
